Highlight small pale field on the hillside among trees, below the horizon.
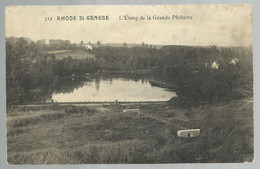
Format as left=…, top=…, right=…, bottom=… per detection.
left=48, top=50, right=95, bottom=59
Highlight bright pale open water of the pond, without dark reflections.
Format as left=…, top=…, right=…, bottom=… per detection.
left=51, top=77, right=176, bottom=102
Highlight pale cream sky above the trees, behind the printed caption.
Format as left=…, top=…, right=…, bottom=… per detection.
left=5, top=5, right=253, bottom=46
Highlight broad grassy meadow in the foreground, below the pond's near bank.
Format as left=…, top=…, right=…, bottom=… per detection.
left=7, top=100, right=253, bottom=164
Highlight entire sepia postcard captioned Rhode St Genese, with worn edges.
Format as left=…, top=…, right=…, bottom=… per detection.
left=5, top=4, right=254, bottom=165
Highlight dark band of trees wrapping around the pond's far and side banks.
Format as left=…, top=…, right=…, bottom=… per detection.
left=6, top=38, right=253, bottom=106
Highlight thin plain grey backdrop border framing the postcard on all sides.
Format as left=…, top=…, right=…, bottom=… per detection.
left=0, top=0, right=260, bottom=169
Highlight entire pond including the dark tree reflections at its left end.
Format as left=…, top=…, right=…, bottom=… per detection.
left=25, top=74, right=176, bottom=103
